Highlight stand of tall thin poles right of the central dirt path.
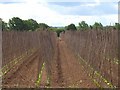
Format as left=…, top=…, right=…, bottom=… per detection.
left=62, top=30, right=119, bottom=87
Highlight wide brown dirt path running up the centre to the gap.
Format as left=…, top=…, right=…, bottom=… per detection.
left=51, top=40, right=96, bottom=88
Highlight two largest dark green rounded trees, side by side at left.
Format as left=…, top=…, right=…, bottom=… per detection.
left=8, top=17, right=39, bottom=31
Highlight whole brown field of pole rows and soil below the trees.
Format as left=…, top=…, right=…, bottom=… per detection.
left=0, top=30, right=119, bottom=88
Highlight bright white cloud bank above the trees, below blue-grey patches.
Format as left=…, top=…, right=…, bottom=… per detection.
left=0, top=0, right=118, bottom=26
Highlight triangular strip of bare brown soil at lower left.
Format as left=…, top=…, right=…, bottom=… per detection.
left=3, top=49, right=38, bottom=88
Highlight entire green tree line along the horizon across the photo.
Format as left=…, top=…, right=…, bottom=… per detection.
left=2, top=17, right=120, bottom=36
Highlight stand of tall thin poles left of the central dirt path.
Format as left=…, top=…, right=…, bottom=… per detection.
left=0, top=30, right=56, bottom=85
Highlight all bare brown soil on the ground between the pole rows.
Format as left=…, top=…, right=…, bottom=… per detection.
left=3, top=39, right=97, bottom=88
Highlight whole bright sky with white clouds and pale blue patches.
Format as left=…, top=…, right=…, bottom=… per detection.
left=0, top=0, right=119, bottom=26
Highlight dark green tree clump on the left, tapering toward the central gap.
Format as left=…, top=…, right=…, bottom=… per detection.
left=2, top=17, right=49, bottom=31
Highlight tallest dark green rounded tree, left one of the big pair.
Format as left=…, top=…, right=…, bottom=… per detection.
left=8, top=17, right=24, bottom=31
